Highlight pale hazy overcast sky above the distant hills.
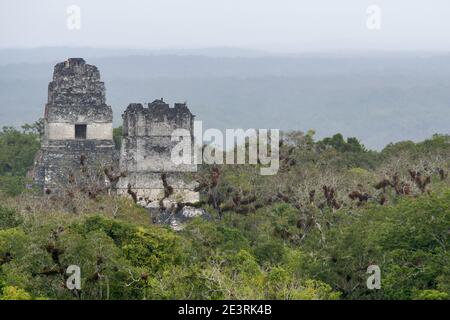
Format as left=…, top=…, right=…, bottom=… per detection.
left=0, top=0, right=450, bottom=52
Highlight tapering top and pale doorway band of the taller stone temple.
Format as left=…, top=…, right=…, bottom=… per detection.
left=44, top=58, right=113, bottom=143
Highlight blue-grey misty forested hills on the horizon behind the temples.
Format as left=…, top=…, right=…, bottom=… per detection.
left=0, top=48, right=450, bottom=148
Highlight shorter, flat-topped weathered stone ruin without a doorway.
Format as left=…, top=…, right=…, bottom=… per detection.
left=118, top=99, right=198, bottom=205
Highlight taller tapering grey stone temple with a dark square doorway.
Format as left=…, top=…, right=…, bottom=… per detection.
left=33, top=58, right=114, bottom=192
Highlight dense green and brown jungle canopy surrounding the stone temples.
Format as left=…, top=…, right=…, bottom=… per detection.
left=0, top=125, right=450, bottom=299
